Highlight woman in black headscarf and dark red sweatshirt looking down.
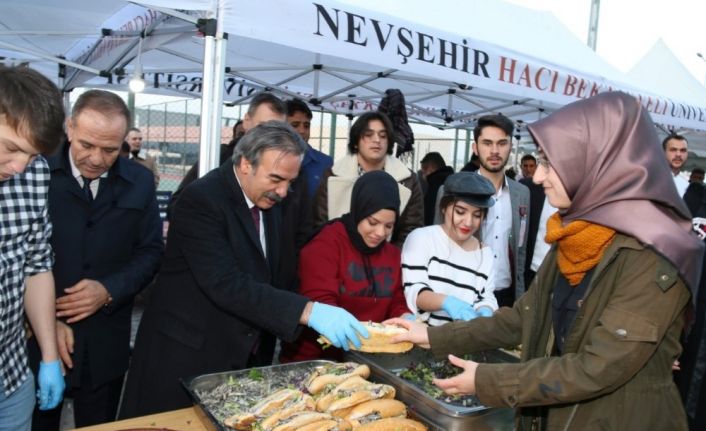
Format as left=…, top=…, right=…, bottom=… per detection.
left=281, top=171, right=409, bottom=362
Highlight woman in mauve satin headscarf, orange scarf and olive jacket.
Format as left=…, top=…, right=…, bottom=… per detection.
left=384, top=93, right=703, bottom=431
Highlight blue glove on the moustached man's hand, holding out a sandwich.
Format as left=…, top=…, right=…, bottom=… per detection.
left=308, top=302, right=370, bottom=350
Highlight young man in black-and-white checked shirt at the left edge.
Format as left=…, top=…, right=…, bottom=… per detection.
left=0, top=66, right=64, bottom=431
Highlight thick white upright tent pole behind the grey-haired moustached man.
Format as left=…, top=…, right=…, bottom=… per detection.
left=199, top=19, right=226, bottom=177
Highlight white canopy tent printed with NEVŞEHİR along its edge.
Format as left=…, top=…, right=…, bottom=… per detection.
left=5, top=0, right=706, bottom=172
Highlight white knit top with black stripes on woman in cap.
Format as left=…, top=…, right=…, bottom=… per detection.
left=402, top=225, right=498, bottom=326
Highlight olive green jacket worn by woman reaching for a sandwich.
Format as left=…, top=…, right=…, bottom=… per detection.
left=429, top=234, right=691, bottom=431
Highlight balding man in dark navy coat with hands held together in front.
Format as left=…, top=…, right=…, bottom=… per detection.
left=29, top=90, right=163, bottom=430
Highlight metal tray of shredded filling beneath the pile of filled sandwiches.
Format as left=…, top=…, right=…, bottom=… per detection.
left=181, top=360, right=331, bottom=431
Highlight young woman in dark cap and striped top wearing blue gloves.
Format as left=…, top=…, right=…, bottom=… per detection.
left=402, top=172, right=498, bottom=326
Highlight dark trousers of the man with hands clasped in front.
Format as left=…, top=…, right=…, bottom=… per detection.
left=32, top=361, right=123, bottom=431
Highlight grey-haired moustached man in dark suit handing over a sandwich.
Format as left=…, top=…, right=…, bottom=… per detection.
left=121, top=121, right=368, bottom=417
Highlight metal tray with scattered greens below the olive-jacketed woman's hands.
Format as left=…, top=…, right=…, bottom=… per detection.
left=346, top=347, right=518, bottom=431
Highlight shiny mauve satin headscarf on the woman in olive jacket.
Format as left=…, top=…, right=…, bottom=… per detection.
left=528, top=92, right=704, bottom=297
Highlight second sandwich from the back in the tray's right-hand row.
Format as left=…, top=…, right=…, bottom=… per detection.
left=316, top=376, right=395, bottom=416
